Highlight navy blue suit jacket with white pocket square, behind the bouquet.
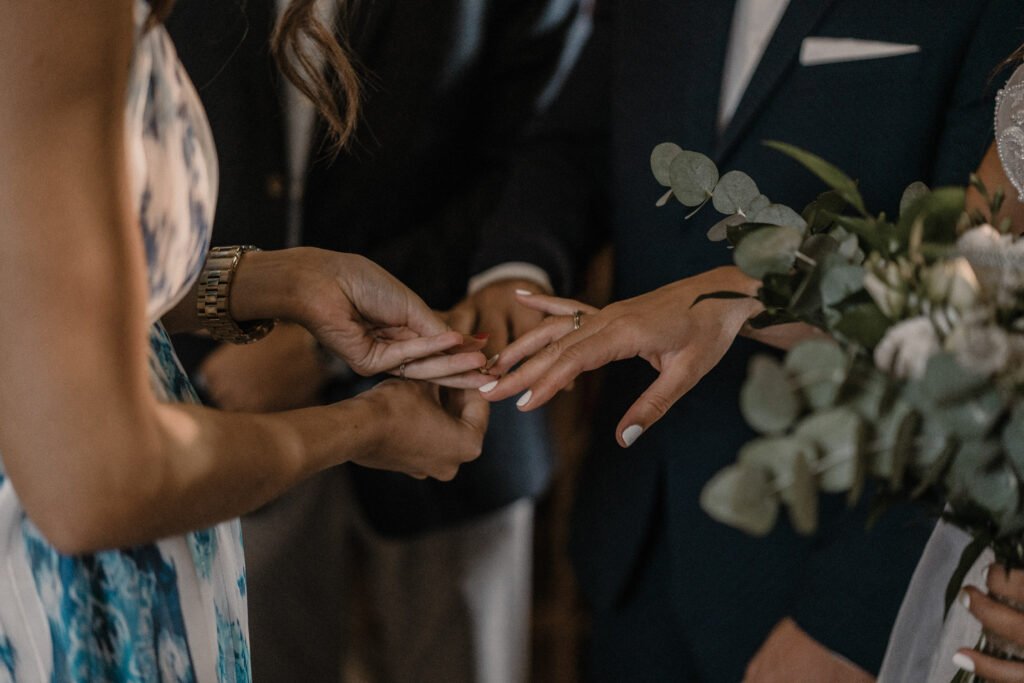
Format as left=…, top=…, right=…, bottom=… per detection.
left=476, top=0, right=1024, bottom=683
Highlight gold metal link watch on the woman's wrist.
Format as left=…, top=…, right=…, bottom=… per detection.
left=196, top=245, right=274, bottom=344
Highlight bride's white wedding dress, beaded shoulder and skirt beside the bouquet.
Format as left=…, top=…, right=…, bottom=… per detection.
left=879, top=61, right=1024, bottom=683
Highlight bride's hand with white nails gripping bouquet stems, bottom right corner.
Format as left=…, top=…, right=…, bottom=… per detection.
left=953, top=564, right=1024, bottom=683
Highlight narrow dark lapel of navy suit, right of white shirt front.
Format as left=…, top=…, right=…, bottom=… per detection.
left=715, top=0, right=836, bottom=161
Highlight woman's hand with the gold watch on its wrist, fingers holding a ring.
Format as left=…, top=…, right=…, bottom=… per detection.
left=231, top=248, right=486, bottom=388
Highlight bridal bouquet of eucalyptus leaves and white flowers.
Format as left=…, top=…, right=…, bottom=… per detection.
left=651, top=142, right=1024, bottom=634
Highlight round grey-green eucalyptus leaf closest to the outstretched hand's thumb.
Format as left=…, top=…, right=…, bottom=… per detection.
left=739, top=355, right=801, bottom=434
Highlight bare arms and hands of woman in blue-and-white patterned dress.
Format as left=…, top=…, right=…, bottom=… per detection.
left=0, top=0, right=487, bottom=554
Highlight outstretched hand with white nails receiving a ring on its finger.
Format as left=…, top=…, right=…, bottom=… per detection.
left=481, top=266, right=761, bottom=446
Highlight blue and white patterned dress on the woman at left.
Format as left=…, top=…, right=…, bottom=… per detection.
left=0, top=0, right=251, bottom=683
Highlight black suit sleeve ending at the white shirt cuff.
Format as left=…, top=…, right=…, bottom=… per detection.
left=471, top=2, right=611, bottom=294
